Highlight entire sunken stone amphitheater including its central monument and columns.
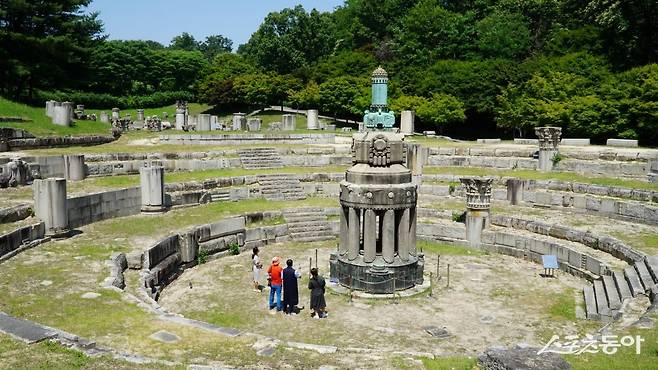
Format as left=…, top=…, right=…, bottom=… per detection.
left=0, top=68, right=658, bottom=369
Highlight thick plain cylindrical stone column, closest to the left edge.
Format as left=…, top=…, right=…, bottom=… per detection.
left=32, top=178, right=69, bottom=238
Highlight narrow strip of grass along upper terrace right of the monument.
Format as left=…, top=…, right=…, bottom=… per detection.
left=424, top=166, right=658, bottom=190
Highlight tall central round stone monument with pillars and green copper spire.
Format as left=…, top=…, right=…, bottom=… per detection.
left=330, top=68, right=424, bottom=294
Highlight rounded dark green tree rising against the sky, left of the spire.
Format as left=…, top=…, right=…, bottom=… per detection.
left=238, top=5, right=335, bottom=74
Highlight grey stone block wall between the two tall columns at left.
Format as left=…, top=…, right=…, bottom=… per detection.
left=67, top=187, right=142, bottom=228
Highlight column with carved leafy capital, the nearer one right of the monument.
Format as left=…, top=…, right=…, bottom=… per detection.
left=459, top=177, right=493, bottom=248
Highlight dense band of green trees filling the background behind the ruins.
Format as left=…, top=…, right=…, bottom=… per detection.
left=0, top=0, right=658, bottom=145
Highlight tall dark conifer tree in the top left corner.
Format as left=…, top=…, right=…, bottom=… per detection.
left=0, top=0, right=103, bottom=98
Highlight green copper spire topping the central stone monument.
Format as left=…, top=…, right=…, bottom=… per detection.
left=363, top=66, right=395, bottom=130
